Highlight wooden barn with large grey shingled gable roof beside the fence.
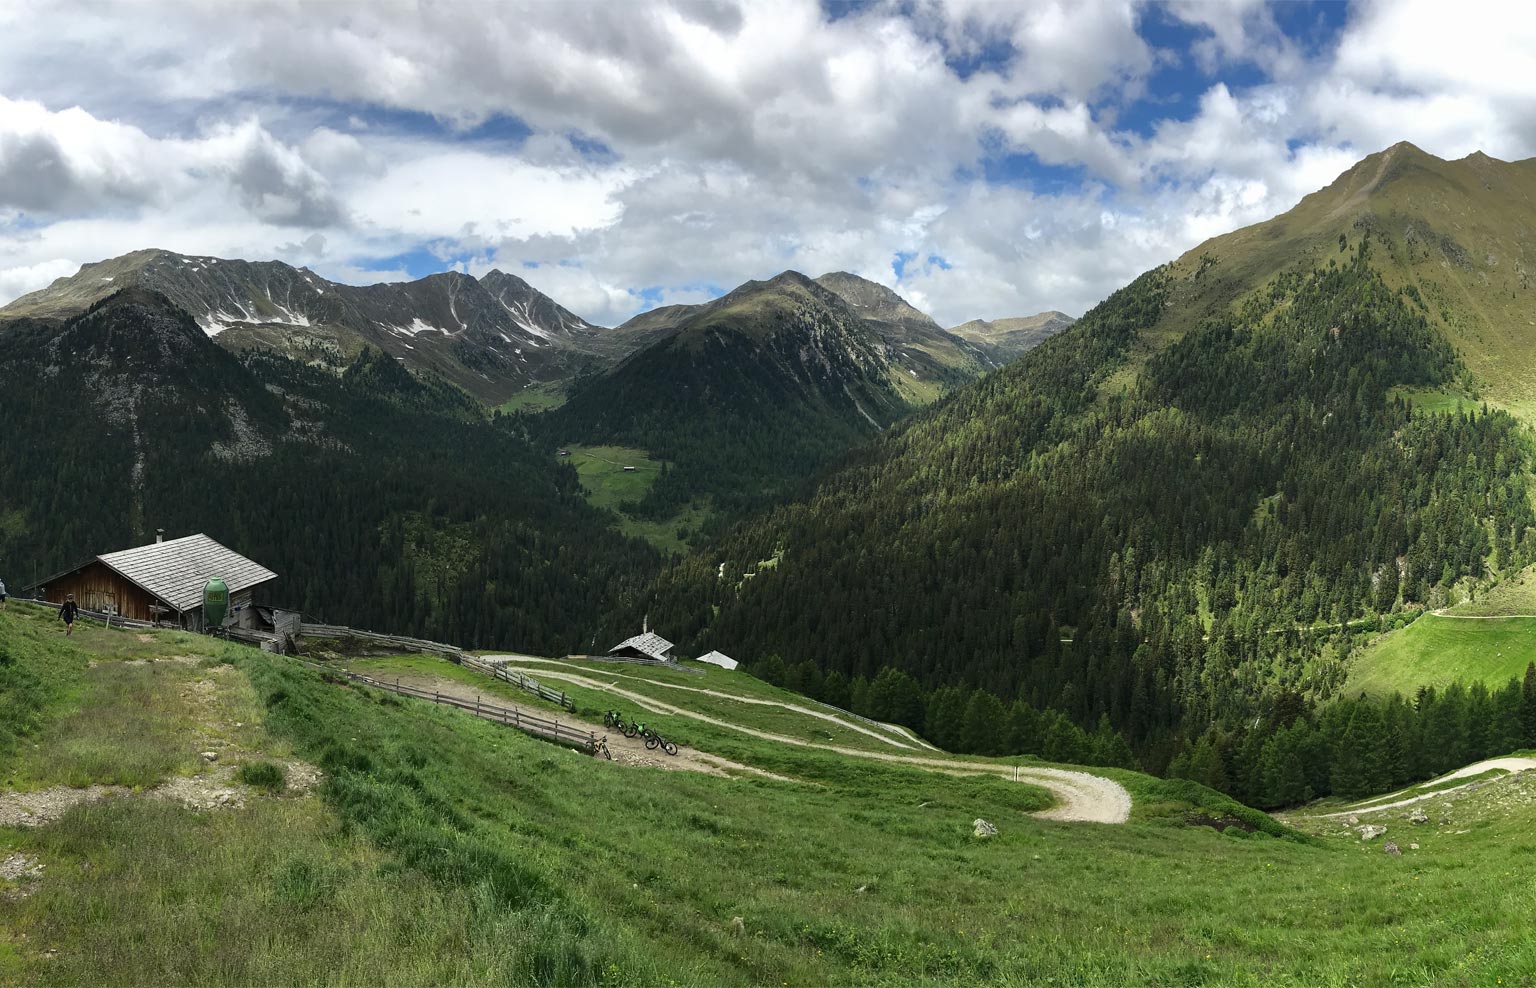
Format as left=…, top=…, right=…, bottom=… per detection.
left=31, top=533, right=278, bottom=632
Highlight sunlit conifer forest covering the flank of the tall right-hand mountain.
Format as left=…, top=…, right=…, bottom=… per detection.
left=650, top=232, right=1536, bottom=770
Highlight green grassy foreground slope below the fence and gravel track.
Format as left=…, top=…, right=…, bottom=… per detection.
left=9, top=610, right=1536, bottom=985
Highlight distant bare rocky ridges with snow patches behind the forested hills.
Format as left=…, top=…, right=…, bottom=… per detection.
left=0, top=249, right=1062, bottom=406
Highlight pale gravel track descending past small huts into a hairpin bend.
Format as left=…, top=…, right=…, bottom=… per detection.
left=485, top=662, right=1130, bottom=824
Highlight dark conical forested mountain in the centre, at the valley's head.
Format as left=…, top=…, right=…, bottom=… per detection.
left=543, top=272, right=912, bottom=534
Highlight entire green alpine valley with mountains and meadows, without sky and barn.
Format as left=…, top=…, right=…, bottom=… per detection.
left=12, top=143, right=1536, bottom=986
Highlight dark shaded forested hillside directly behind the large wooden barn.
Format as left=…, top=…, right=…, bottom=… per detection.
left=0, top=289, right=656, bottom=651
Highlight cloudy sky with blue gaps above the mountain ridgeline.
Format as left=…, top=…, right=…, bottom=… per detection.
left=0, top=0, right=1536, bottom=326
